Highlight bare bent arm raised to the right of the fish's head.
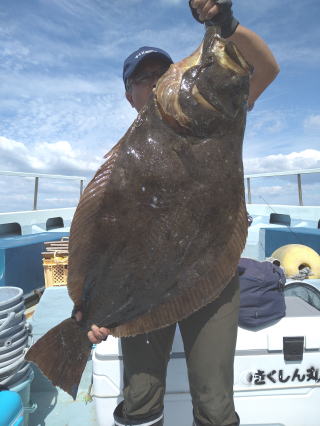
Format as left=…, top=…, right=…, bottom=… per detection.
left=228, top=25, right=280, bottom=106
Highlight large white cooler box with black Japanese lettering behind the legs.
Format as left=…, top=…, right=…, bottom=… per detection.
left=93, top=297, right=320, bottom=426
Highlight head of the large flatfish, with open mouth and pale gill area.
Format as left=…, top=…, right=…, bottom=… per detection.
left=155, top=27, right=252, bottom=137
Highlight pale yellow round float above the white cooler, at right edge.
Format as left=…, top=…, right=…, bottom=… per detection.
left=272, top=244, right=320, bottom=278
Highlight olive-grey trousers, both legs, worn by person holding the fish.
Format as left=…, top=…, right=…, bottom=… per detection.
left=122, top=276, right=239, bottom=426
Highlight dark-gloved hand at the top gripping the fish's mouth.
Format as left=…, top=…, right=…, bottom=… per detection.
left=189, top=0, right=239, bottom=38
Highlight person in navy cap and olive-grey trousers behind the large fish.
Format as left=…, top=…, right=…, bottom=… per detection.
left=76, top=0, right=279, bottom=426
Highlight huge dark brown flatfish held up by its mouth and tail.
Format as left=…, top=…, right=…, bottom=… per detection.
left=27, top=27, right=250, bottom=397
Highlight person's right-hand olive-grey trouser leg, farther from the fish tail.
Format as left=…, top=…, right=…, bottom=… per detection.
left=179, top=276, right=239, bottom=426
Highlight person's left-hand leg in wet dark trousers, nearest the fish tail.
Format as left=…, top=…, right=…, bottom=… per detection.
left=114, top=324, right=176, bottom=426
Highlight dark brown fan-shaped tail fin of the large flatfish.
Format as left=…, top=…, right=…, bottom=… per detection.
left=25, top=318, right=92, bottom=399
